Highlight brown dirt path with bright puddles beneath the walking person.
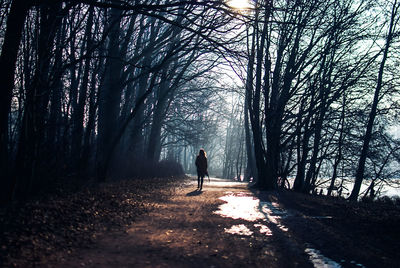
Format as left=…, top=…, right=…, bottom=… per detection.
left=56, top=178, right=313, bottom=267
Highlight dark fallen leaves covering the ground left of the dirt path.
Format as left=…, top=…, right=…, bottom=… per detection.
left=0, top=177, right=181, bottom=267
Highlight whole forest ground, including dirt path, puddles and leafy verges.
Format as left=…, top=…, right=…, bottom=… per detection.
left=0, top=178, right=400, bottom=267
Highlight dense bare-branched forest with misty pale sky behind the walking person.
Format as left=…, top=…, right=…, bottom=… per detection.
left=0, top=0, right=400, bottom=203
